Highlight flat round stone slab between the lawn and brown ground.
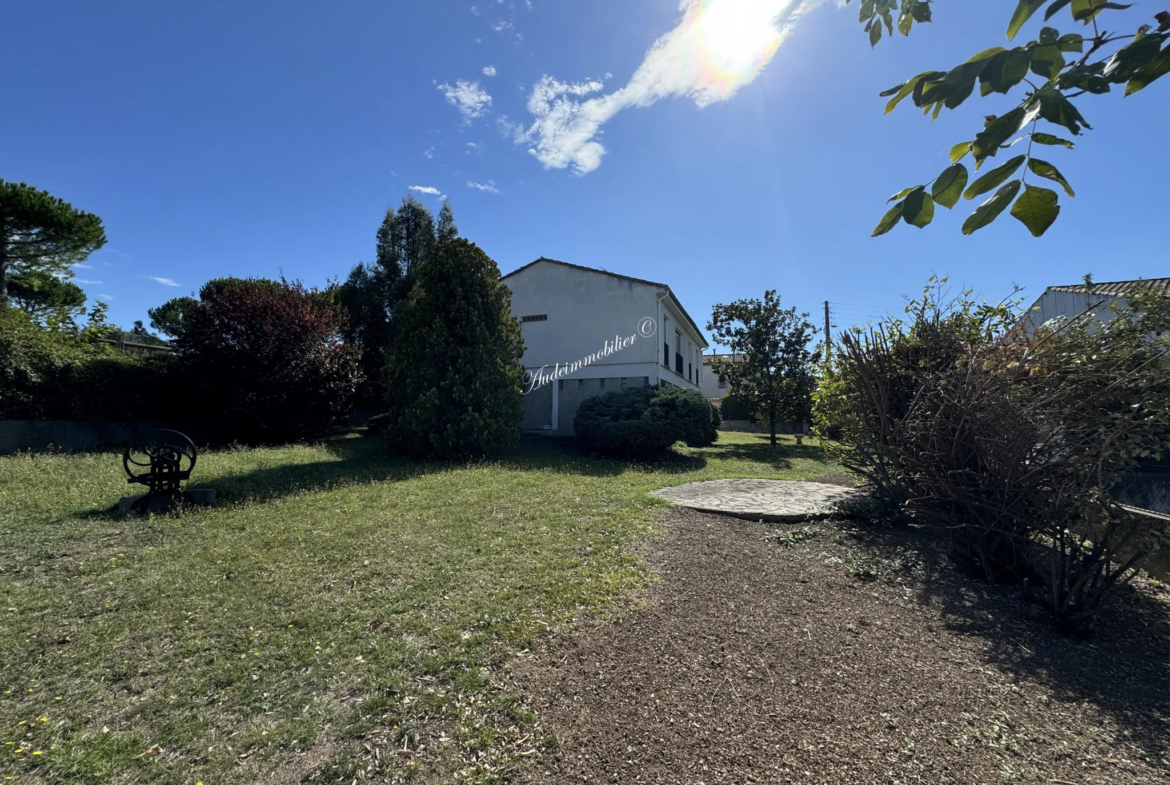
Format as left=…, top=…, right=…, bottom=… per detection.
left=651, top=480, right=861, bottom=523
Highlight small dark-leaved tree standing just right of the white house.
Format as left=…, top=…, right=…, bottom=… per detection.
left=707, top=290, right=819, bottom=446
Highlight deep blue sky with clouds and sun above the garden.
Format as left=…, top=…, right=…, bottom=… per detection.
left=0, top=0, right=1170, bottom=343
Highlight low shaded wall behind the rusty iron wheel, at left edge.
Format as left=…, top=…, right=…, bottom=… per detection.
left=0, top=420, right=221, bottom=455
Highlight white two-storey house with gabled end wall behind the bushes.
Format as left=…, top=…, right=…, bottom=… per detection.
left=502, top=256, right=708, bottom=436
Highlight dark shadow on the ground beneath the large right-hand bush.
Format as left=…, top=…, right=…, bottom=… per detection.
left=855, top=528, right=1170, bottom=765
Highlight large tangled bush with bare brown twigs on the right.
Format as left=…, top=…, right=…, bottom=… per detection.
left=818, top=283, right=1170, bottom=629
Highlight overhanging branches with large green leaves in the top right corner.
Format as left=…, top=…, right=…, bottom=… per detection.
left=846, top=0, right=1170, bottom=237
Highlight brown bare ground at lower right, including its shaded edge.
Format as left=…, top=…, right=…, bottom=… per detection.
left=512, top=510, right=1170, bottom=785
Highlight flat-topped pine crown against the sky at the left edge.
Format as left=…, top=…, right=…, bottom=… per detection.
left=0, top=180, right=105, bottom=310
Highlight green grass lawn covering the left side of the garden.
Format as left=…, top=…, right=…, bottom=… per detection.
left=0, top=434, right=832, bottom=785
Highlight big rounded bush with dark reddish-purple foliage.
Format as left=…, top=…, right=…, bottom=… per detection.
left=170, top=278, right=362, bottom=440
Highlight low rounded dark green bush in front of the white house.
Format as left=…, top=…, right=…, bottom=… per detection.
left=573, top=387, right=720, bottom=460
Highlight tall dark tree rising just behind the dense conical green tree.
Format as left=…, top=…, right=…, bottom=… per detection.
left=337, top=197, right=459, bottom=401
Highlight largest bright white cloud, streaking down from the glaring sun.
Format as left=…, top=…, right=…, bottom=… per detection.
left=517, top=0, right=823, bottom=174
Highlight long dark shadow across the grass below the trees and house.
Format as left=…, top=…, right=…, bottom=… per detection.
left=80, top=431, right=707, bottom=519
